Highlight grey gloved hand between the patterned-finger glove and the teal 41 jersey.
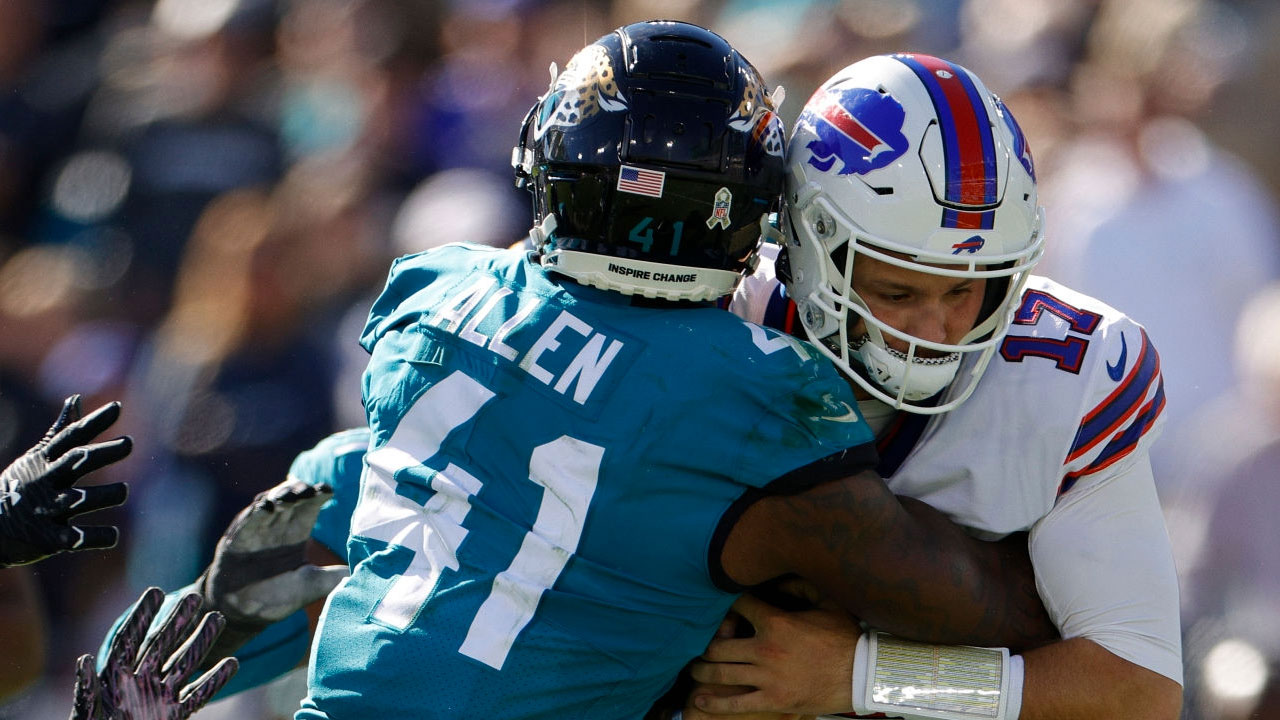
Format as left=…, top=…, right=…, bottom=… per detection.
left=196, top=479, right=347, bottom=659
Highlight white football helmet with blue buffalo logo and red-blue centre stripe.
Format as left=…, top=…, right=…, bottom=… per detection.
left=780, top=54, right=1043, bottom=414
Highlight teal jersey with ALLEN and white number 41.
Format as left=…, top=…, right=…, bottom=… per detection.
left=296, top=245, right=872, bottom=720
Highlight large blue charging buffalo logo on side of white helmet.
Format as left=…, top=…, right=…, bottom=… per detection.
left=799, top=87, right=909, bottom=176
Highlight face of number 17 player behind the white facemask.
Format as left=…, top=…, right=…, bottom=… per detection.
left=852, top=249, right=987, bottom=357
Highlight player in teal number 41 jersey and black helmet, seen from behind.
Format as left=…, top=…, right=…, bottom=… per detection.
left=296, top=22, right=1052, bottom=720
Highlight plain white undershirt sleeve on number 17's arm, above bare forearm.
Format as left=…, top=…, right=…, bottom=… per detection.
left=1029, top=452, right=1183, bottom=684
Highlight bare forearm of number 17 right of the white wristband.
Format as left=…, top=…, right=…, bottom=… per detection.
left=1019, top=638, right=1183, bottom=720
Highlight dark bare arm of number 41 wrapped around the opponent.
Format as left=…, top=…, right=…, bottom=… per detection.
left=724, top=475, right=1057, bottom=648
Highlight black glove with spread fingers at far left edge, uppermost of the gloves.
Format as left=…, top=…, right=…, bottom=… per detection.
left=0, top=395, right=133, bottom=568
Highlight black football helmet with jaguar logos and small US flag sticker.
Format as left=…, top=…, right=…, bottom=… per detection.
left=512, top=20, right=785, bottom=301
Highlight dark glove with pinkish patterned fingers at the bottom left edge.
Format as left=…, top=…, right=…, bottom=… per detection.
left=70, top=588, right=239, bottom=720
